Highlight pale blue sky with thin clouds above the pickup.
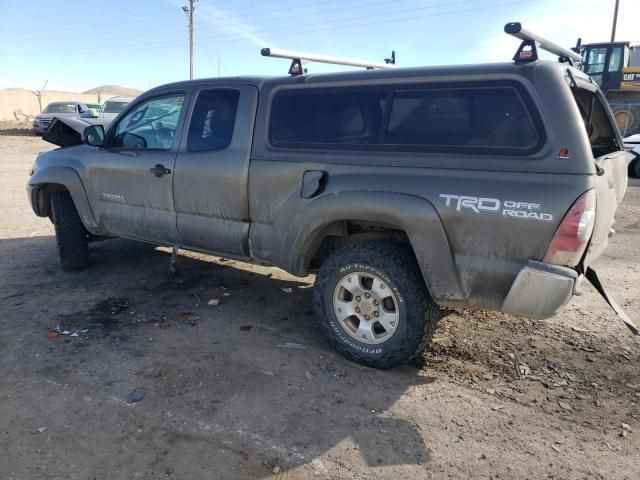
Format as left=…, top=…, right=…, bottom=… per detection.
left=0, top=0, right=640, bottom=91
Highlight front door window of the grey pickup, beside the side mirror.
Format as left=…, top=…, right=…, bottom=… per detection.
left=111, top=93, right=184, bottom=150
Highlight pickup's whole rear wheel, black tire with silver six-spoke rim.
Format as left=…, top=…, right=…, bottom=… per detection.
left=314, top=242, right=442, bottom=368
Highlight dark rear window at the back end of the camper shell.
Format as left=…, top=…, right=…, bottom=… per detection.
left=571, top=88, right=620, bottom=158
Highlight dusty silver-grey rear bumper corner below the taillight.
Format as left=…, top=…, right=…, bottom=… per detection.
left=501, top=260, right=578, bottom=319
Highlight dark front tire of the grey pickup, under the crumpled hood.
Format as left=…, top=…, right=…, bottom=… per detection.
left=51, top=191, right=89, bottom=270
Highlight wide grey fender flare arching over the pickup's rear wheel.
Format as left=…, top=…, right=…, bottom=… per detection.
left=281, top=191, right=466, bottom=302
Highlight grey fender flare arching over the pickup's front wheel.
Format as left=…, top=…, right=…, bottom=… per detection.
left=29, top=166, right=99, bottom=233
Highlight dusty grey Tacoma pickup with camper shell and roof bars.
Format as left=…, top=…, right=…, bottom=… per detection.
left=28, top=24, right=637, bottom=368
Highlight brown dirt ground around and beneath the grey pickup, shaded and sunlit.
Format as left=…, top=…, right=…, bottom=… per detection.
left=0, top=124, right=640, bottom=480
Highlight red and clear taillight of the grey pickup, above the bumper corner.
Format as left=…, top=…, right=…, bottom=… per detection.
left=544, top=190, right=596, bottom=267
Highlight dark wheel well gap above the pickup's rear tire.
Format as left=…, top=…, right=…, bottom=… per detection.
left=306, top=220, right=414, bottom=271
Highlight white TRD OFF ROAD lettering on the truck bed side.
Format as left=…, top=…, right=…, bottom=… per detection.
left=440, top=193, right=553, bottom=222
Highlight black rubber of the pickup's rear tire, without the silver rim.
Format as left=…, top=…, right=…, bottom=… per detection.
left=314, top=241, right=443, bottom=369
